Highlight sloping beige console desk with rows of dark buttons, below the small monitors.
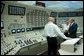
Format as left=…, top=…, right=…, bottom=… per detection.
left=1, top=30, right=46, bottom=55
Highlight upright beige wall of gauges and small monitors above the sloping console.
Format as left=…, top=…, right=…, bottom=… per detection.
left=1, top=1, right=52, bottom=36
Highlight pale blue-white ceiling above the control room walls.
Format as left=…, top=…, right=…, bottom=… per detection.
left=17, top=1, right=83, bottom=12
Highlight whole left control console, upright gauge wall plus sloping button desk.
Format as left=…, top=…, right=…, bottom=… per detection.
left=1, top=1, right=51, bottom=55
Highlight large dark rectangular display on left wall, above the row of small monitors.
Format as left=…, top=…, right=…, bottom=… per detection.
left=8, top=5, right=26, bottom=15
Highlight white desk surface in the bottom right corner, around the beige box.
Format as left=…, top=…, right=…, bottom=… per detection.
left=58, top=43, right=83, bottom=55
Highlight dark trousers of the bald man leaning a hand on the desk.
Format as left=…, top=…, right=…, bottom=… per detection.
left=47, top=37, right=57, bottom=55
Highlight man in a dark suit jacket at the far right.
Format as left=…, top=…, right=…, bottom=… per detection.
left=68, top=18, right=78, bottom=38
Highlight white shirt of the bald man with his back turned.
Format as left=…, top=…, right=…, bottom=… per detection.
left=44, top=22, right=68, bottom=39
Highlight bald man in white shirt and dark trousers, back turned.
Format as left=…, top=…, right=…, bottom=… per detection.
left=44, top=17, right=69, bottom=55
